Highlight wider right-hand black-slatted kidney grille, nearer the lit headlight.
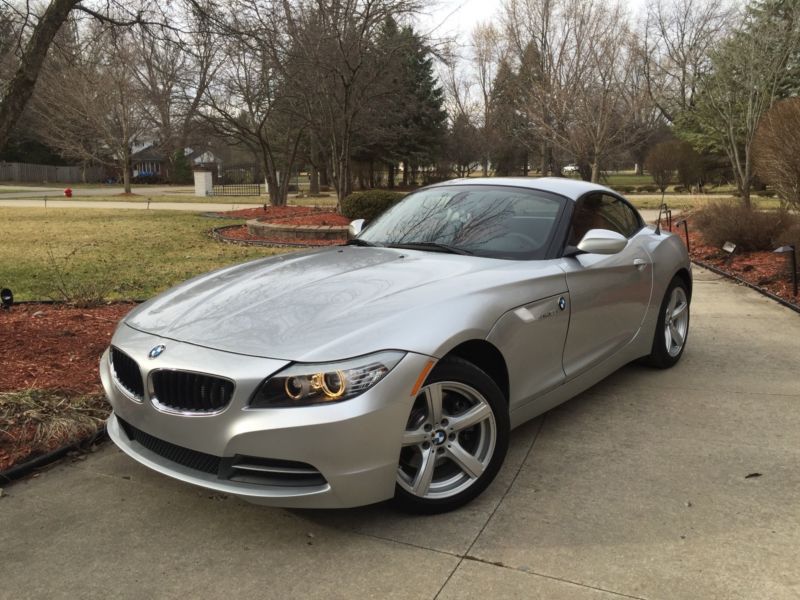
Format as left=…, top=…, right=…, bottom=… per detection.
left=150, top=370, right=234, bottom=414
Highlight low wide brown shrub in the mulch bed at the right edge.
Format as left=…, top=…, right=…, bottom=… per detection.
left=692, top=202, right=797, bottom=250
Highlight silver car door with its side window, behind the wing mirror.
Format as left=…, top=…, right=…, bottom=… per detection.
left=562, top=192, right=653, bottom=379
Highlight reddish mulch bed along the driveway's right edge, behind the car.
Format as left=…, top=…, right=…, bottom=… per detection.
left=673, top=219, right=800, bottom=307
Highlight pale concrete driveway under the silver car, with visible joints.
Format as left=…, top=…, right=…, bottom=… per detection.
left=0, top=270, right=800, bottom=600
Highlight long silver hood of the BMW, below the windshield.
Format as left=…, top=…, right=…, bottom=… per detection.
left=124, top=246, right=566, bottom=361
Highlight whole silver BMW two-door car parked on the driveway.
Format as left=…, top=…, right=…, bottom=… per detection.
left=100, top=178, right=692, bottom=512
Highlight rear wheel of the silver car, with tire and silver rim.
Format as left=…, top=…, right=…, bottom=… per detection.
left=645, top=276, right=689, bottom=369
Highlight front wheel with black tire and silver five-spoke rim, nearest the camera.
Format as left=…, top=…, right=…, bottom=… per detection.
left=394, top=357, right=510, bottom=514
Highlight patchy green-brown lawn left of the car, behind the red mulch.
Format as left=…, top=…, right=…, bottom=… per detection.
left=0, top=208, right=296, bottom=301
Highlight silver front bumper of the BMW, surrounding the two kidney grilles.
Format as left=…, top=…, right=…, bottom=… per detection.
left=100, top=325, right=438, bottom=508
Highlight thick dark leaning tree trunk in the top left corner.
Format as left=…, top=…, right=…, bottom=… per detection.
left=0, top=0, right=80, bottom=150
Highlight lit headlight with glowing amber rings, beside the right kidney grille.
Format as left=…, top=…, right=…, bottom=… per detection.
left=250, top=351, right=405, bottom=408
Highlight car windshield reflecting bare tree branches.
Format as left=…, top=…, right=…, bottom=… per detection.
left=358, top=185, right=563, bottom=260
